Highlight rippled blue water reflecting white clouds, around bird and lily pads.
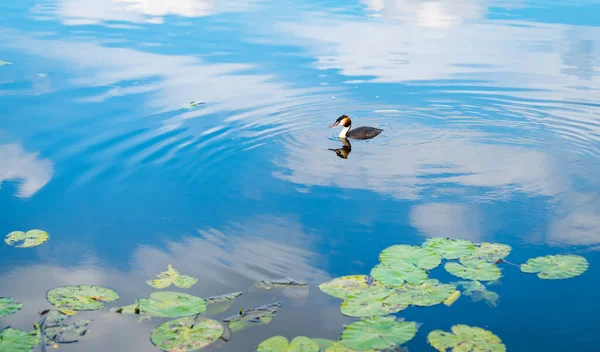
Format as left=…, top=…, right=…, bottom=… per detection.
left=0, top=0, right=600, bottom=352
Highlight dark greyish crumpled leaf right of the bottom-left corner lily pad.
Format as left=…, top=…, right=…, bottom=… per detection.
left=42, top=310, right=92, bottom=343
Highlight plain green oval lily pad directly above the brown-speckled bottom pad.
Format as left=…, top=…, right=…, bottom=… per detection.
left=136, top=291, right=206, bottom=318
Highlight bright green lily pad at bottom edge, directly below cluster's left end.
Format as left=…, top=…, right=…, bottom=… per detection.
left=341, top=317, right=417, bottom=351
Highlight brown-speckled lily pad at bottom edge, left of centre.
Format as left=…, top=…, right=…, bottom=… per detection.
left=152, top=317, right=224, bottom=352
